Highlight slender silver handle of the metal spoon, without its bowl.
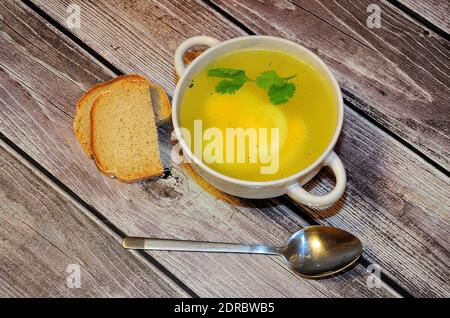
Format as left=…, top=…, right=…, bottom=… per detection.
left=122, top=237, right=281, bottom=255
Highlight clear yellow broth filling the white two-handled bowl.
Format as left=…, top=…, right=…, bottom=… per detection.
left=180, top=49, right=338, bottom=181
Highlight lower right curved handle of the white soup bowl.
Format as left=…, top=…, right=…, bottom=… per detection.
left=286, top=151, right=347, bottom=208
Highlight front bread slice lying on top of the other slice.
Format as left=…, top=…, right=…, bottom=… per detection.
left=90, top=75, right=163, bottom=182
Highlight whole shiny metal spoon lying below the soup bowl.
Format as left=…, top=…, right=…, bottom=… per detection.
left=122, top=226, right=362, bottom=278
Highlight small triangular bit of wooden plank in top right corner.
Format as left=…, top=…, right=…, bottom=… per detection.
left=398, top=0, right=450, bottom=34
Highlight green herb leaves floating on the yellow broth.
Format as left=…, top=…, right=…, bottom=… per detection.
left=208, top=68, right=297, bottom=105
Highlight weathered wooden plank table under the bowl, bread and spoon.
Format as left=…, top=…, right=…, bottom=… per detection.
left=0, top=0, right=450, bottom=297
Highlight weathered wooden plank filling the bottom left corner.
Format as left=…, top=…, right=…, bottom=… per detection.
left=0, top=141, right=186, bottom=297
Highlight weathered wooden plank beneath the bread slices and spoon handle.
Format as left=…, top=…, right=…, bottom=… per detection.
left=0, top=3, right=395, bottom=297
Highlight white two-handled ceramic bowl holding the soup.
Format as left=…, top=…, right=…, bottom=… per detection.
left=172, top=36, right=347, bottom=208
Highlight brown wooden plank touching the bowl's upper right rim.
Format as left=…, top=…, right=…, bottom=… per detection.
left=213, top=0, right=450, bottom=170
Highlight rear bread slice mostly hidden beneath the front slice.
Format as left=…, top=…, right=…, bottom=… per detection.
left=73, top=75, right=172, bottom=156
